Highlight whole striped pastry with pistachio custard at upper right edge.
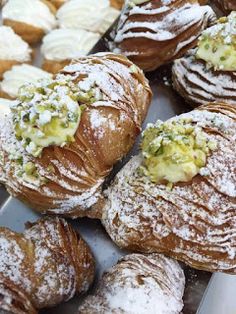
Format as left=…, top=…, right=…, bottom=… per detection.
left=172, top=12, right=236, bottom=106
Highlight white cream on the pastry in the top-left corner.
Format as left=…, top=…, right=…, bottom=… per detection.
left=2, top=0, right=57, bottom=33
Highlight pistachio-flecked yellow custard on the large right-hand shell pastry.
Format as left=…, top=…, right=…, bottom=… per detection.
left=141, top=119, right=216, bottom=184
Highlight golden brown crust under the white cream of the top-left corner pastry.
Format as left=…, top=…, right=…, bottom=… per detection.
left=3, top=19, right=44, bottom=44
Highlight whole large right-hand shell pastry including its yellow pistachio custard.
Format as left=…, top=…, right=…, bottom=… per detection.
left=103, top=103, right=236, bottom=274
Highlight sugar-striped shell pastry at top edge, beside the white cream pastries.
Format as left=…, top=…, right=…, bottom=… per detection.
left=111, top=0, right=215, bottom=71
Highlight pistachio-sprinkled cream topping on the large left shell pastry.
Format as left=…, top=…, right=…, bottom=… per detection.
left=12, top=76, right=101, bottom=157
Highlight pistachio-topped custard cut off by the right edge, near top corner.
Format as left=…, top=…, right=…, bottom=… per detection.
left=196, top=12, right=236, bottom=71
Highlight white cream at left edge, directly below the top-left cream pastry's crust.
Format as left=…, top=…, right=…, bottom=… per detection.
left=0, top=26, right=32, bottom=62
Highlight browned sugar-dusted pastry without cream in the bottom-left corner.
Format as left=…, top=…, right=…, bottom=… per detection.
left=0, top=217, right=94, bottom=314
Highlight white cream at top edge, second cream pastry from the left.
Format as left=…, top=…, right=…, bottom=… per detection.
left=57, top=0, right=120, bottom=34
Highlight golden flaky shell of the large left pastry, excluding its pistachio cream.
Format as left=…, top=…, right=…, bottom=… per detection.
left=0, top=53, right=151, bottom=217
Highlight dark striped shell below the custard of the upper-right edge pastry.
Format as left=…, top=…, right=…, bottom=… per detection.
left=172, top=50, right=236, bottom=106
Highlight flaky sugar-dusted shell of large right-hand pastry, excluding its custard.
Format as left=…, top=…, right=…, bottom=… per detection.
left=103, top=104, right=236, bottom=274
